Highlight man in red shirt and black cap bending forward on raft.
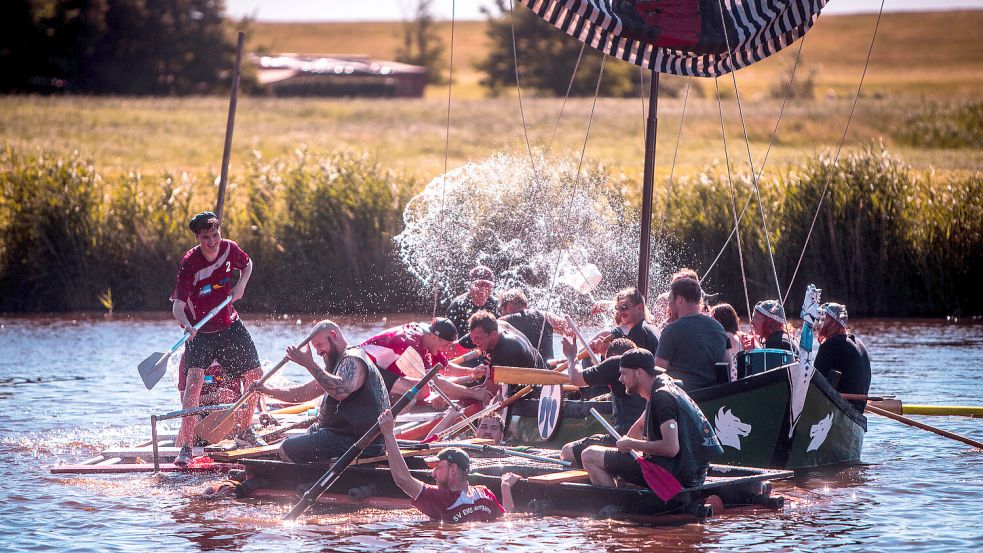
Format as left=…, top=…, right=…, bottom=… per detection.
left=359, top=317, right=491, bottom=407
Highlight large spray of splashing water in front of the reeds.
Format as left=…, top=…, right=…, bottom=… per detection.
left=395, top=154, right=672, bottom=314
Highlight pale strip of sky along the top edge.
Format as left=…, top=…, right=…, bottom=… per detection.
left=225, top=0, right=983, bottom=21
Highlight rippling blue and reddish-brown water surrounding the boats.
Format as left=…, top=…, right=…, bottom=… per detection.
left=0, top=315, right=983, bottom=552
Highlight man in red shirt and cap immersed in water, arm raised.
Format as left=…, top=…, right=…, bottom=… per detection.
left=379, top=409, right=505, bottom=522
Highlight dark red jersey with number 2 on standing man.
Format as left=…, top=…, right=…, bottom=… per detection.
left=173, top=240, right=249, bottom=332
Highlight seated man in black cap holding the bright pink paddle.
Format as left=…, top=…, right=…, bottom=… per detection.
left=581, top=348, right=723, bottom=487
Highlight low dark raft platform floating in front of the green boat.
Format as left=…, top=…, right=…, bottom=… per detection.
left=242, top=459, right=792, bottom=518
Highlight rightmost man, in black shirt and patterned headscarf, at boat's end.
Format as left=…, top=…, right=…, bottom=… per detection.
left=813, top=302, right=870, bottom=413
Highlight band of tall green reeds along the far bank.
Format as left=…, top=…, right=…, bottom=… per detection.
left=0, top=147, right=983, bottom=316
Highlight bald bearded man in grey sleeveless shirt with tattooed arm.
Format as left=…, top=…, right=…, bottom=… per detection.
left=256, top=321, right=389, bottom=463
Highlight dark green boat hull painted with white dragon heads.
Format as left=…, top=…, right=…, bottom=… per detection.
left=508, top=368, right=867, bottom=470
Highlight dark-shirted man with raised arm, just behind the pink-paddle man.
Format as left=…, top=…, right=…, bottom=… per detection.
left=560, top=338, right=645, bottom=465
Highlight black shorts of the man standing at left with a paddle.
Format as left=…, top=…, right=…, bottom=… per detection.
left=184, top=319, right=260, bottom=378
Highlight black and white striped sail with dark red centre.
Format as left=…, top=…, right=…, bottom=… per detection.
left=519, top=0, right=827, bottom=77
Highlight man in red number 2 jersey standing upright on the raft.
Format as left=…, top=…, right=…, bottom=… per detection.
left=172, top=211, right=264, bottom=466
